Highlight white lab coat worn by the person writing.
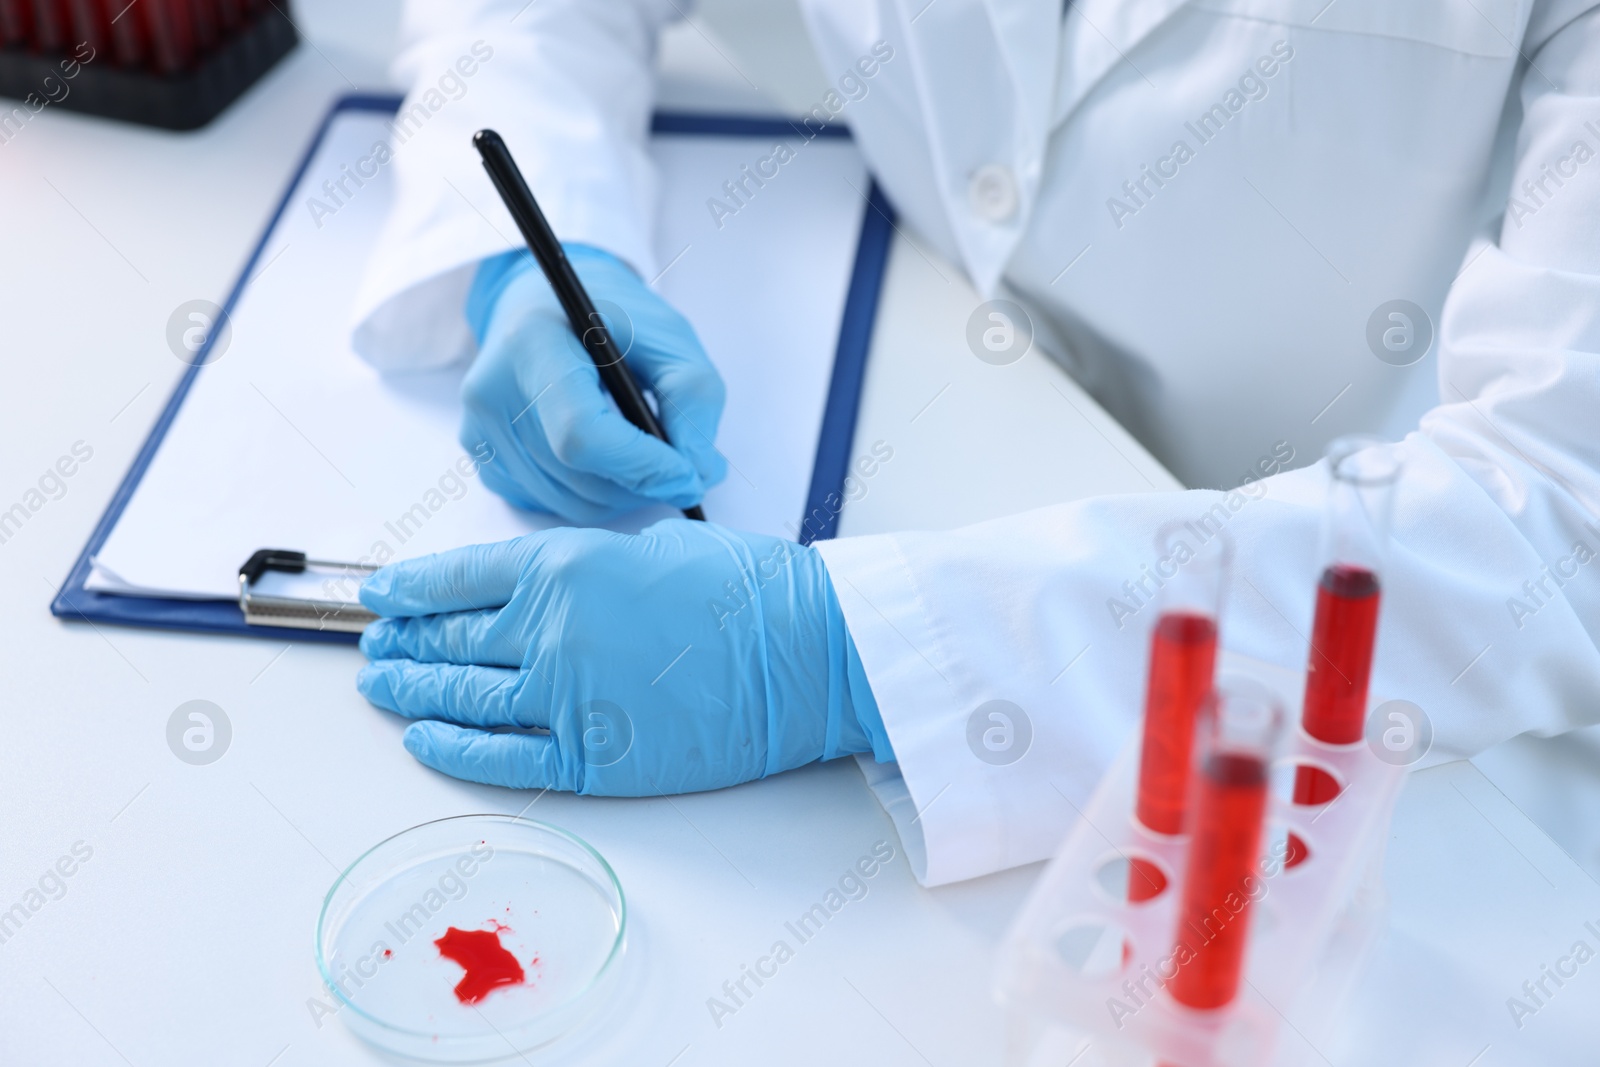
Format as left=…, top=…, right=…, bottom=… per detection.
left=355, top=0, right=1600, bottom=885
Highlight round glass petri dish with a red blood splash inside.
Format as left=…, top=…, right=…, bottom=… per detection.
left=317, top=814, right=627, bottom=1064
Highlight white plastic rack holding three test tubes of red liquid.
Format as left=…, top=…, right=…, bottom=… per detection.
left=995, top=651, right=1406, bottom=1067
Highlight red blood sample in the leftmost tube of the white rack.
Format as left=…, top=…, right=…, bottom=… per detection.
left=1136, top=611, right=1216, bottom=833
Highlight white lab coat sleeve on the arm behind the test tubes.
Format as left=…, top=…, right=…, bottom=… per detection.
left=821, top=5, right=1600, bottom=885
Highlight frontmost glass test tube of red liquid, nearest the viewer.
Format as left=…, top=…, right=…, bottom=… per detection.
left=1166, top=678, right=1283, bottom=1008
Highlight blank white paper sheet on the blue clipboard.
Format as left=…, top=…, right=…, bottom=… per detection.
left=88, top=114, right=867, bottom=598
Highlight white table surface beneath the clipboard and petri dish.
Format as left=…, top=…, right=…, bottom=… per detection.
left=0, top=3, right=1600, bottom=1067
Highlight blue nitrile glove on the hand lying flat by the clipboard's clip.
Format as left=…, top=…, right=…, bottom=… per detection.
left=357, top=518, right=894, bottom=797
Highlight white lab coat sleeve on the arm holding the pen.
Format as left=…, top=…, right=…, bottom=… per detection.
left=350, top=0, right=680, bottom=370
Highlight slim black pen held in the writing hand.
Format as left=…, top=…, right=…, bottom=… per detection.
left=472, top=130, right=706, bottom=520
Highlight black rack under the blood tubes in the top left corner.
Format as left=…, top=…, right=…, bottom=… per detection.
left=0, top=5, right=299, bottom=133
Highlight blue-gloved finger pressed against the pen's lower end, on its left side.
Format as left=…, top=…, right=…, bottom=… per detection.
left=539, top=365, right=706, bottom=507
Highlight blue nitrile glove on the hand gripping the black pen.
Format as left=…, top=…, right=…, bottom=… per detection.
left=461, top=245, right=728, bottom=523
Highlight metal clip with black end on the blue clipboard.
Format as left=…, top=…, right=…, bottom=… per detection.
left=238, top=549, right=378, bottom=633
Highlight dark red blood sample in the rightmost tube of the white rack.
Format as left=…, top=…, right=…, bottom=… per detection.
left=1301, top=563, right=1381, bottom=745
